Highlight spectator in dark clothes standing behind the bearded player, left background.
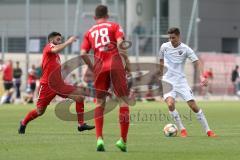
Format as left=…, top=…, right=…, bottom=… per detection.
left=13, top=61, right=22, bottom=100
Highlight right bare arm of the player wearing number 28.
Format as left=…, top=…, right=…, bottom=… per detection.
left=117, top=37, right=131, bottom=74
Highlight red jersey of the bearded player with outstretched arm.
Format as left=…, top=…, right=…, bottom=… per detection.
left=40, top=43, right=62, bottom=84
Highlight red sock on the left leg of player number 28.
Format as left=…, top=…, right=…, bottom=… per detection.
left=94, top=106, right=104, bottom=139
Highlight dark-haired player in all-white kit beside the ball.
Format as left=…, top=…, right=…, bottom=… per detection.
left=159, top=27, right=216, bottom=137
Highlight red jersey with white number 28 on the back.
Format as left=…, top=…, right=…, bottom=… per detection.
left=81, top=21, right=124, bottom=71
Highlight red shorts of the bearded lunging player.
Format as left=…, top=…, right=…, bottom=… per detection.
left=37, top=83, right=75, bottom=108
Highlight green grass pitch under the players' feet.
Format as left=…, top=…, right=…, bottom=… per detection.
left=0, top=102, right=240, bottom=160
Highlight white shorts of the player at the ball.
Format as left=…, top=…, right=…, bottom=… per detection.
left=163, top=82, right=195, bottom=102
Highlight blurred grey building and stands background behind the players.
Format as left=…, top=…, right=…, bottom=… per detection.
left=0, top=0, right=240, bottom=102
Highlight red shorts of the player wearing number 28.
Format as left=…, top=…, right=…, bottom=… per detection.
left=94, top=69, right=129, bottom=98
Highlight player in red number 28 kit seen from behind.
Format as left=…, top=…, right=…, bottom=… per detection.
left=81, top=5, right=130, bottom=152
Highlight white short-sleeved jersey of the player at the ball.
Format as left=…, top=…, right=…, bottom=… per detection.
left=159, top=42, right=198, bottom=84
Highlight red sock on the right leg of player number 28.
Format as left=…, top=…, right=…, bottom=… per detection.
left=119, top=106, right=129, bottom=143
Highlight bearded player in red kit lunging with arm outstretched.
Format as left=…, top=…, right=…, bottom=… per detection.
left=18, top=32, right=94, bottom=134
